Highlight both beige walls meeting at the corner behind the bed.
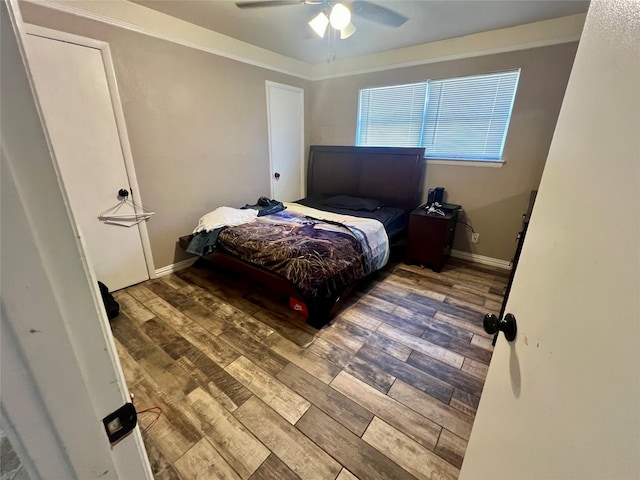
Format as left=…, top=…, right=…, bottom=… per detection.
left=21, top=2, right=576, bottom=268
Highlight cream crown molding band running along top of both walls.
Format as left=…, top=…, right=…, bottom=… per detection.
left=22, top=0, right=586, bottom=81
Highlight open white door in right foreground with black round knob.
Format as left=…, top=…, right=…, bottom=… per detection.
left=460, top=0, right=640, bottom=480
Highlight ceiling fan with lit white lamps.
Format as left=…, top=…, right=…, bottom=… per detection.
left=236, top=0, right=408, bottom=39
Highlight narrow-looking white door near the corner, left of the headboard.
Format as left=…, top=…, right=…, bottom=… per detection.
left=267, top=82, right=304, bottom=202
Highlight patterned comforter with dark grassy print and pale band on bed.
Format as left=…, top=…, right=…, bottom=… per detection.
left=218, top=203, right=389, bottom=299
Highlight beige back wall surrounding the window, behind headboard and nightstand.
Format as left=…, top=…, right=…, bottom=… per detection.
left=308, top=43, right=577, bottom=260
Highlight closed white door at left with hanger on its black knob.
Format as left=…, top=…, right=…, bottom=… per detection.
left=26, top=35, right=149, bottom=290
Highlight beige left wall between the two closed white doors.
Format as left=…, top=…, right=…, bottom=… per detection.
left=20, top=2, right=309, bottom=268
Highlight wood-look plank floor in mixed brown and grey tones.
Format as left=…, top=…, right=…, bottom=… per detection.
left=111, top=260, right=507, bottom=480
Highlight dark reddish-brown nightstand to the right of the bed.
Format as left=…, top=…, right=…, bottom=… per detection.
left=405, top=204, right=460, bottom=272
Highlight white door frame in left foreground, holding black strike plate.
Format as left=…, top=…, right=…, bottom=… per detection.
left=0, top=0, right=153, bottom=480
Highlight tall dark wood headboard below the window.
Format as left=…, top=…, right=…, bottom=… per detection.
left=307, top=145, right=425, bottom=210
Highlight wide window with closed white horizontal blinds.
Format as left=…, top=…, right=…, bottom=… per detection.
left=356, top=69, right=520, bottom=162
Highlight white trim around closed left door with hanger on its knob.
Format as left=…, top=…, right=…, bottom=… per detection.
left=24, top=23, right=156, bottom=278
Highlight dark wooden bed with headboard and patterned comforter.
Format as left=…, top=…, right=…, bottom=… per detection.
left=179, top=145, right=425, bottom=328
